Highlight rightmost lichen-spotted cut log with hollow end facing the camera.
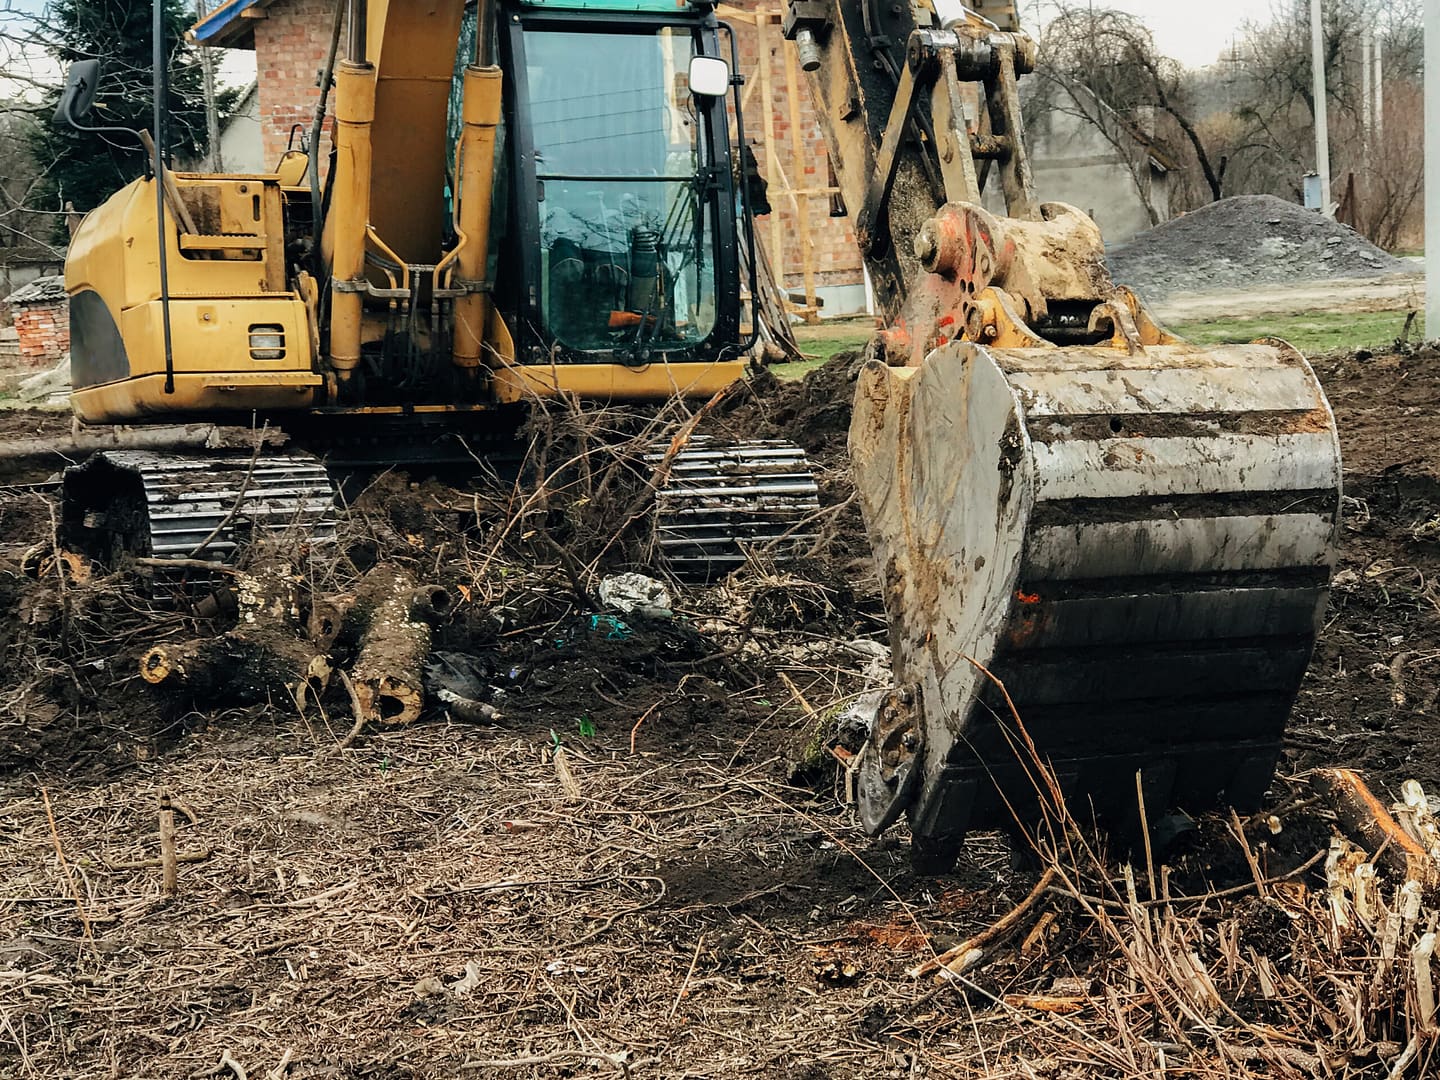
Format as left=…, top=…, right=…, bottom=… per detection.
left=347, top=564, right=451, bottom=724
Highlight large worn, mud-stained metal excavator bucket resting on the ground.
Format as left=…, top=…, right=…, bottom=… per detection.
left=850, top=341, right=1341, bottom=861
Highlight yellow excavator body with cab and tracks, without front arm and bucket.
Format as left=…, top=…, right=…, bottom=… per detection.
left=56, top=0, right=818, bottom=573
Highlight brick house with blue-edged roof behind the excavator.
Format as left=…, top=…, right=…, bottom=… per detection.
left=192, top=0, right=867, bottom=315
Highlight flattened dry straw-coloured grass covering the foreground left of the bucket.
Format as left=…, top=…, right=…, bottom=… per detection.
left=0, top=720, right=1013, bottom=1076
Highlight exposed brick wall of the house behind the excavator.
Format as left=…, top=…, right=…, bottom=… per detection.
left=246, top=0, right=864, bottom=292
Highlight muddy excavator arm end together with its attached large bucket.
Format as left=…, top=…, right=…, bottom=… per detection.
left=785, top=0, right=1341, bottom=871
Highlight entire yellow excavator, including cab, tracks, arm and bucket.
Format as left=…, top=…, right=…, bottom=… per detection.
left=60, top=0, right=1341, bottom=871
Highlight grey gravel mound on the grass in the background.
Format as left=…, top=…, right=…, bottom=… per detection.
left=1107, top=194, right=1411, bottom=301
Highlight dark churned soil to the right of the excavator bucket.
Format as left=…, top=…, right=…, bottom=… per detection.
left=1287, top=350, right=1440, bottom=792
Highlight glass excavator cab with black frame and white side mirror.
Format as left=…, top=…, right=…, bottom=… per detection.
left=501, top=4, right=744, bottom=366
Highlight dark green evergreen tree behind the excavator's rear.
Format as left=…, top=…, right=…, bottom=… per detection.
left=29, top=0, right=235, bottom=238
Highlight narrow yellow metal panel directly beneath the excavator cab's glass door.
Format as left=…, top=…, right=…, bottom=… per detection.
left=494, top=360, right=746, bottom=402
